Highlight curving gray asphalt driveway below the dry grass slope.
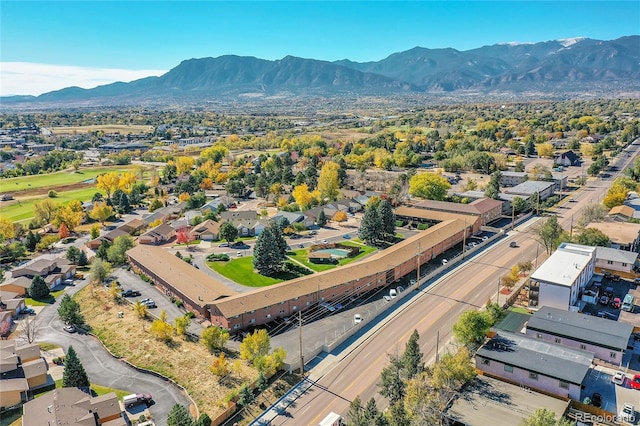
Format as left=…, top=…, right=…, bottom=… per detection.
left=37, top=274, right=190, bottom=425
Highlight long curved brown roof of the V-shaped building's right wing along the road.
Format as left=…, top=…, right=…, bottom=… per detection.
left=210, top=220, right=470, bottom=318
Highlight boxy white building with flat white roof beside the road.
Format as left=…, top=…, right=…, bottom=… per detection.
left=529, top=243, right=596, bottom=310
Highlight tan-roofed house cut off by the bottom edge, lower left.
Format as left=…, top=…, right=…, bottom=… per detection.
left=22, top=388, right=127, bottom=426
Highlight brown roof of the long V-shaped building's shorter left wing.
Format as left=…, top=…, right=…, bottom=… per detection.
left=127, top=245, right=236, bottom=306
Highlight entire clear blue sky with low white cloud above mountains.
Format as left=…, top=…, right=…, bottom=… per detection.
left=0, top=0, right=640, bottom=95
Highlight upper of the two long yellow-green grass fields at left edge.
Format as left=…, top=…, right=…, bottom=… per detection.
left=0, top=166, right=139, bottom=192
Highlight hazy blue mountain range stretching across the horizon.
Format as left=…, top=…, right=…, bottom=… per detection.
left=1, top=35, right=640, bottom=105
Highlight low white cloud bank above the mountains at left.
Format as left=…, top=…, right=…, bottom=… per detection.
left=0, top=62, right=166, bottom=96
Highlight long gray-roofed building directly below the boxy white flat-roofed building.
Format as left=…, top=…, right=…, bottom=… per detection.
left=526, top=306, right=633, bottom=365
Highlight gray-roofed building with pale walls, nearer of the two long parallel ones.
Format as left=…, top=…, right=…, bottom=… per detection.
left=475, top=331, right=594, bottom=401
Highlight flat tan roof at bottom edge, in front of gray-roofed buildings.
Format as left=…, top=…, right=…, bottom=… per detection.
left=443, top=376, right=569, bottom=426
